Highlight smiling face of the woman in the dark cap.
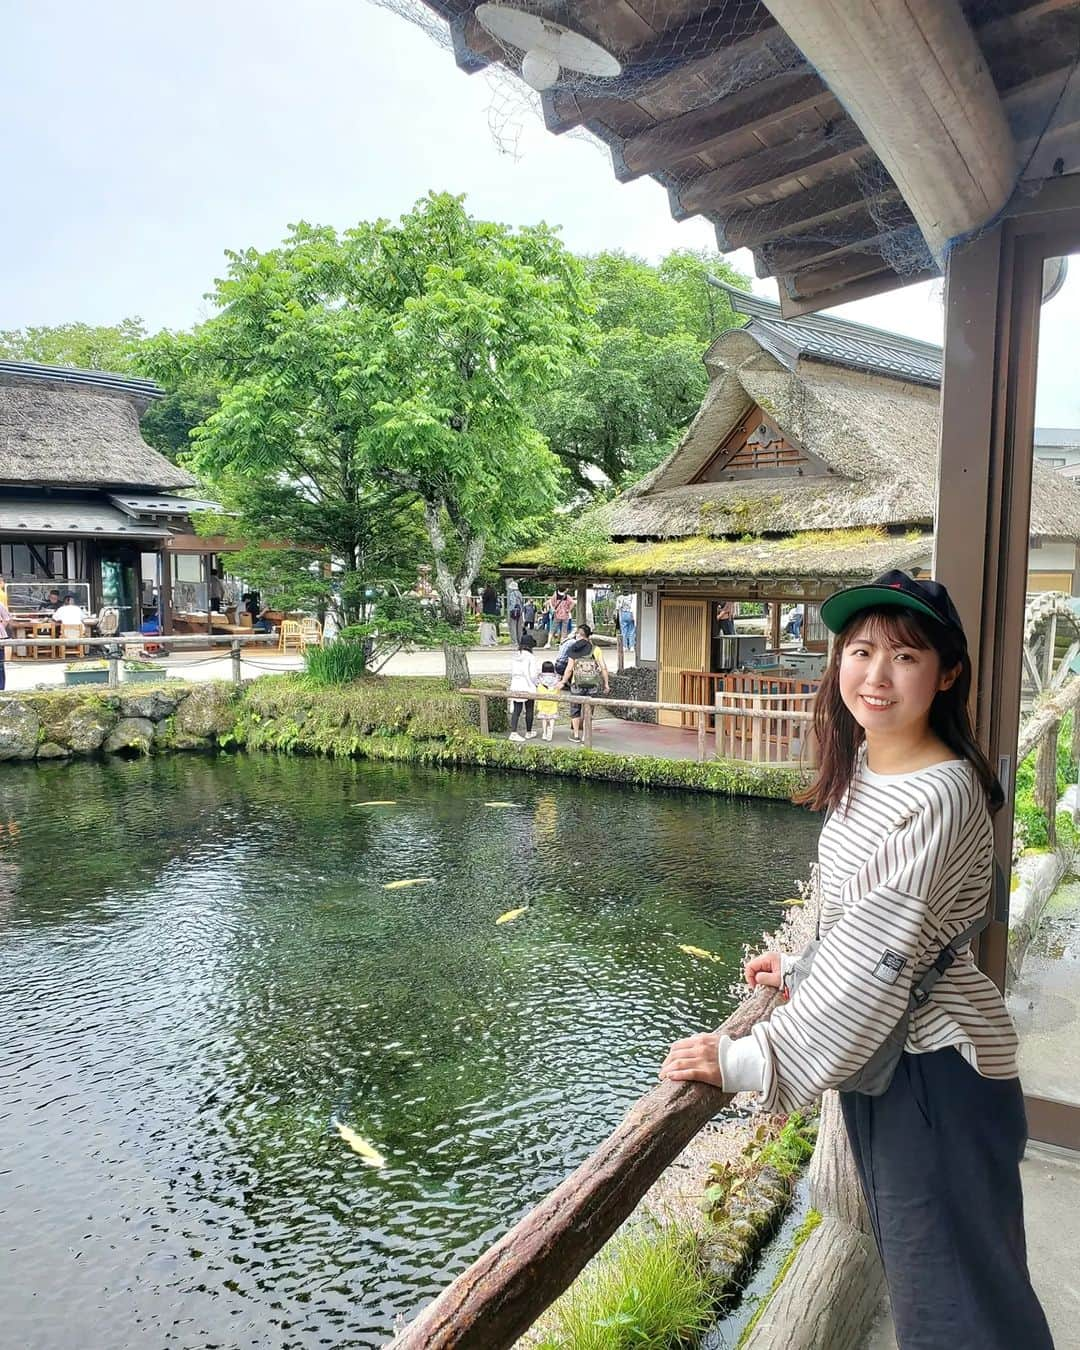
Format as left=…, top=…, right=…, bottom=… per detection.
left=840, top=624, right=960, bottom=738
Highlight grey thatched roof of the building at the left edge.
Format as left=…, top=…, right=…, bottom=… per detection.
left=0, top=363, right=194, bottom=489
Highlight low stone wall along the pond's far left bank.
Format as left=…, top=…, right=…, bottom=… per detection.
left=0, top=680, right=238, bottom=760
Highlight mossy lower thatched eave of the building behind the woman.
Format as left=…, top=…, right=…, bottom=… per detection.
left=502, top=529, right=934, bottom=582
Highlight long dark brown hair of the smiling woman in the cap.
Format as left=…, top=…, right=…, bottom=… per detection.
left=792, top=606, right=1004, bottom=811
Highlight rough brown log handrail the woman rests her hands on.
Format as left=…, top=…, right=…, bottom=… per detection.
left=392, top=990, right=779, bottom=1350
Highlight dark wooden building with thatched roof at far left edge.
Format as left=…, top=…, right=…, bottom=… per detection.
left=0, top=360, right=236, bottom=633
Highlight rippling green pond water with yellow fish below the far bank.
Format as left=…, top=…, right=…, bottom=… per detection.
left=0, top=756, right=817, bottom=1350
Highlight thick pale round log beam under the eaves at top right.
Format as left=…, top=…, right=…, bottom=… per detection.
left=764, top=0, right=1017, bottom=261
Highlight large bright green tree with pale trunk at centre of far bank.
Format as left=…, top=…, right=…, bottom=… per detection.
left=143, top=194, right=585, bottom=682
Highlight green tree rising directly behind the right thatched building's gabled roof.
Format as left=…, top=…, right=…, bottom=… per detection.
left=535, top=251, right=747, bottom=491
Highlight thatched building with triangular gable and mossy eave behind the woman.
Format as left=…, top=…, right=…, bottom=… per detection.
left=504, top=288, right=1080, bottom=723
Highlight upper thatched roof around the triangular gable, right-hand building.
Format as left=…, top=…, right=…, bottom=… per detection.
left=597, top=302, right=1080, bottom=540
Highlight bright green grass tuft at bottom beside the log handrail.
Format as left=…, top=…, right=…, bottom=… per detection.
left=537, top=1226, right=713, bottom=1350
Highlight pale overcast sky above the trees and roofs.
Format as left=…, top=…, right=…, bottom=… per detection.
left=0, top=0, right=1080, bottom=427
